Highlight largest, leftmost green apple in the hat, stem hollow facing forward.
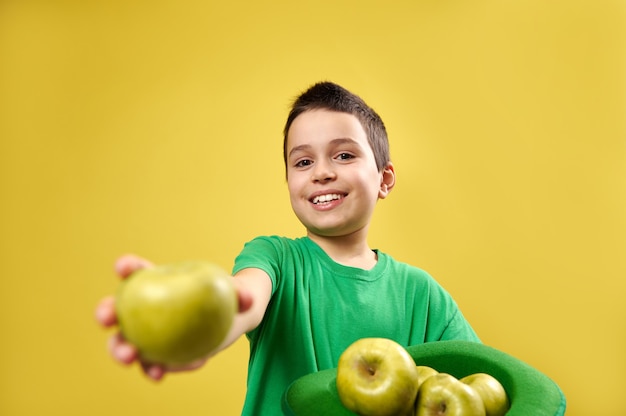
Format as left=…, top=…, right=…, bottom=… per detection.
left=336, top=338, right=418, bottom=416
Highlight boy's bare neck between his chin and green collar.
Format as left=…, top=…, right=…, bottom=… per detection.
left=307, top=231, right=378, bottom=270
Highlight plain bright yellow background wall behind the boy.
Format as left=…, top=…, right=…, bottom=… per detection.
left=0, top=0, right=626, bottom=416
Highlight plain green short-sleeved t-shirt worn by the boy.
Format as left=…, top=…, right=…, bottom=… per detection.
left=233, top=236, right=478, bottom=416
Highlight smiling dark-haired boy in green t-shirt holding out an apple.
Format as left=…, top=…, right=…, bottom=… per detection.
left=98, top=82, right=479, bottom=415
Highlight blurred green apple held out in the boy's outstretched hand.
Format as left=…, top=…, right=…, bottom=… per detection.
left=115, top=261, right=238, bottom=367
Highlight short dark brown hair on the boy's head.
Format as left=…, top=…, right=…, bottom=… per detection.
left=283, top=81, right=391, bottom=172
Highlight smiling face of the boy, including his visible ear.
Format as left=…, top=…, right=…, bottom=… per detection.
left=287, top=110, right=394, bottom=237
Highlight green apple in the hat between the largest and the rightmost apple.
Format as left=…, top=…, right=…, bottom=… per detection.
left=415, top=373, right=485, bottom=416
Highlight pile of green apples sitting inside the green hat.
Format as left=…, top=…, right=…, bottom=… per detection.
left=336, top=338, right=510, bottom=416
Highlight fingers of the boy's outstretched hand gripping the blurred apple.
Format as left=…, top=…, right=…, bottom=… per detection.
left=96, top=255, right=252, bottom=380
